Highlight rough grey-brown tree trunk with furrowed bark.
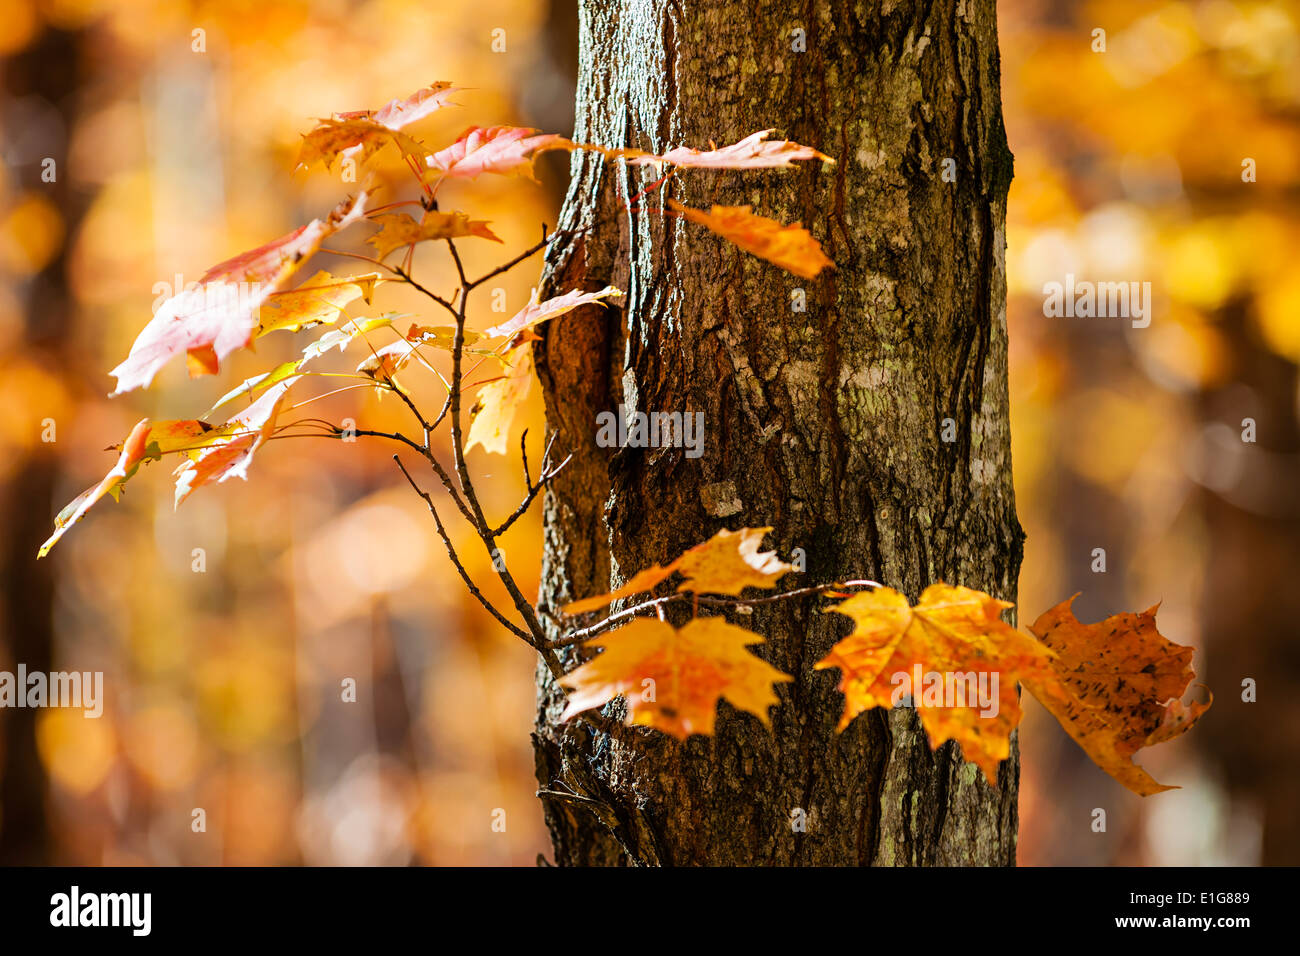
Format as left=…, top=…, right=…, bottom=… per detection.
left=534, top=0, right=1023, bottom=865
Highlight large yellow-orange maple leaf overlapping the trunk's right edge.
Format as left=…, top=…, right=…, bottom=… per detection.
left=814, top=584, right=1050, bottom=783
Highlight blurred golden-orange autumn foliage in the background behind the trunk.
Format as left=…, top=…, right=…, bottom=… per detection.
left=0, top=0, right=1300, bottom=864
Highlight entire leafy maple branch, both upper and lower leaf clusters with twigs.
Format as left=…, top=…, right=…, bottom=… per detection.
left=39, top=83, right=1208, bottom=793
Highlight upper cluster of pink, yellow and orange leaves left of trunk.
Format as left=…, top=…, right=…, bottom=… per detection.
left=39, top=82, right=832, bottom=557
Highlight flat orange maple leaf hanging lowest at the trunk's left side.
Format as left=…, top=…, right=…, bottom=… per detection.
left=560, top=618, right=793, bottom=739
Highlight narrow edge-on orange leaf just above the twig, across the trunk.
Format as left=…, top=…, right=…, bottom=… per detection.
left=564, top=528, right=794, bottom=614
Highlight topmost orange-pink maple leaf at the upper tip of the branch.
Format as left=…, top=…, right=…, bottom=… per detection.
left=298, top=82, right=456, bottom=169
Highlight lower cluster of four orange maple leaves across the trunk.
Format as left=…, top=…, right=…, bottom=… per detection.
left=562, top=528, right=1209, bottom=796
